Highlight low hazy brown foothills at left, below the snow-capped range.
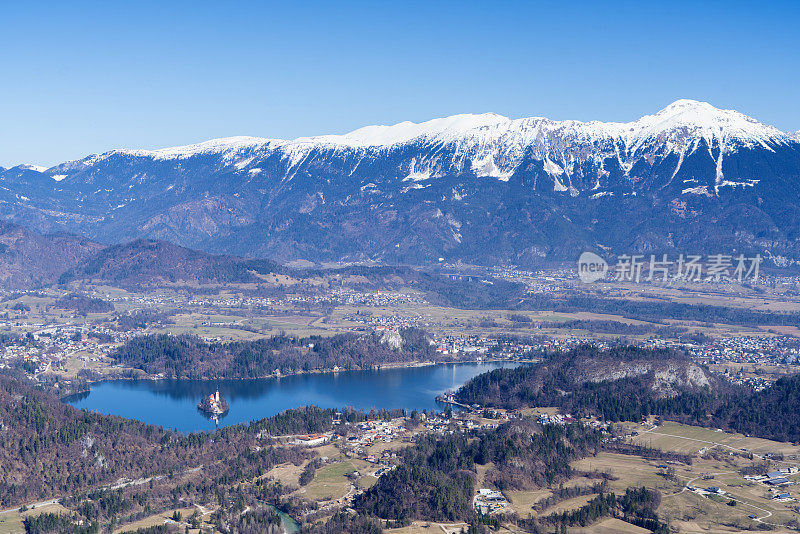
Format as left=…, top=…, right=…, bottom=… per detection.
left=0, top=222, right=524, bottom=308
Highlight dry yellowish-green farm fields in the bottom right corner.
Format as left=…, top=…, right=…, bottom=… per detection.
left=573, top=422, right=800, bottom=533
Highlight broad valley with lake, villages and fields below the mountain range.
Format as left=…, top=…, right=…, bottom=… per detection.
left=0, top=224, right=800, bottom=534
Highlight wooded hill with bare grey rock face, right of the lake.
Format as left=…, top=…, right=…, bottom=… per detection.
left=458, top=346, right=800, bottom=441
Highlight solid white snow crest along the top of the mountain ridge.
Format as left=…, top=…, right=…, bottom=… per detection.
left=72, top=100, right=792, bottom=158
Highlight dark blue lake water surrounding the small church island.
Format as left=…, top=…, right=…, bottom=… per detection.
left=65, top=362, right=519, bottom=432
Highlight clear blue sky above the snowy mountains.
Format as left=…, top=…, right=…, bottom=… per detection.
left=0, top=0, right=800, bottom=166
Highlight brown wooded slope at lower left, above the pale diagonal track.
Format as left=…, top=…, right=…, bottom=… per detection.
left=0, top=376, right=334, bottom=507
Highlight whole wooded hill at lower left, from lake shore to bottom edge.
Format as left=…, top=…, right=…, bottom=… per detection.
left=0, top=374, right=354, bottom=532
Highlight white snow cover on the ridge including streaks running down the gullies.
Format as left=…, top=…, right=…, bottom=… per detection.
left=53, top=100, right=796, bottom=194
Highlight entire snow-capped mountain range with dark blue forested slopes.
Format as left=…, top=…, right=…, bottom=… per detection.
left=0, top=100, right=800, bottom=263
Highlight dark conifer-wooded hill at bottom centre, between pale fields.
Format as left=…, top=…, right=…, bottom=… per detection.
left=354, top=421, right=600, bottom=522
